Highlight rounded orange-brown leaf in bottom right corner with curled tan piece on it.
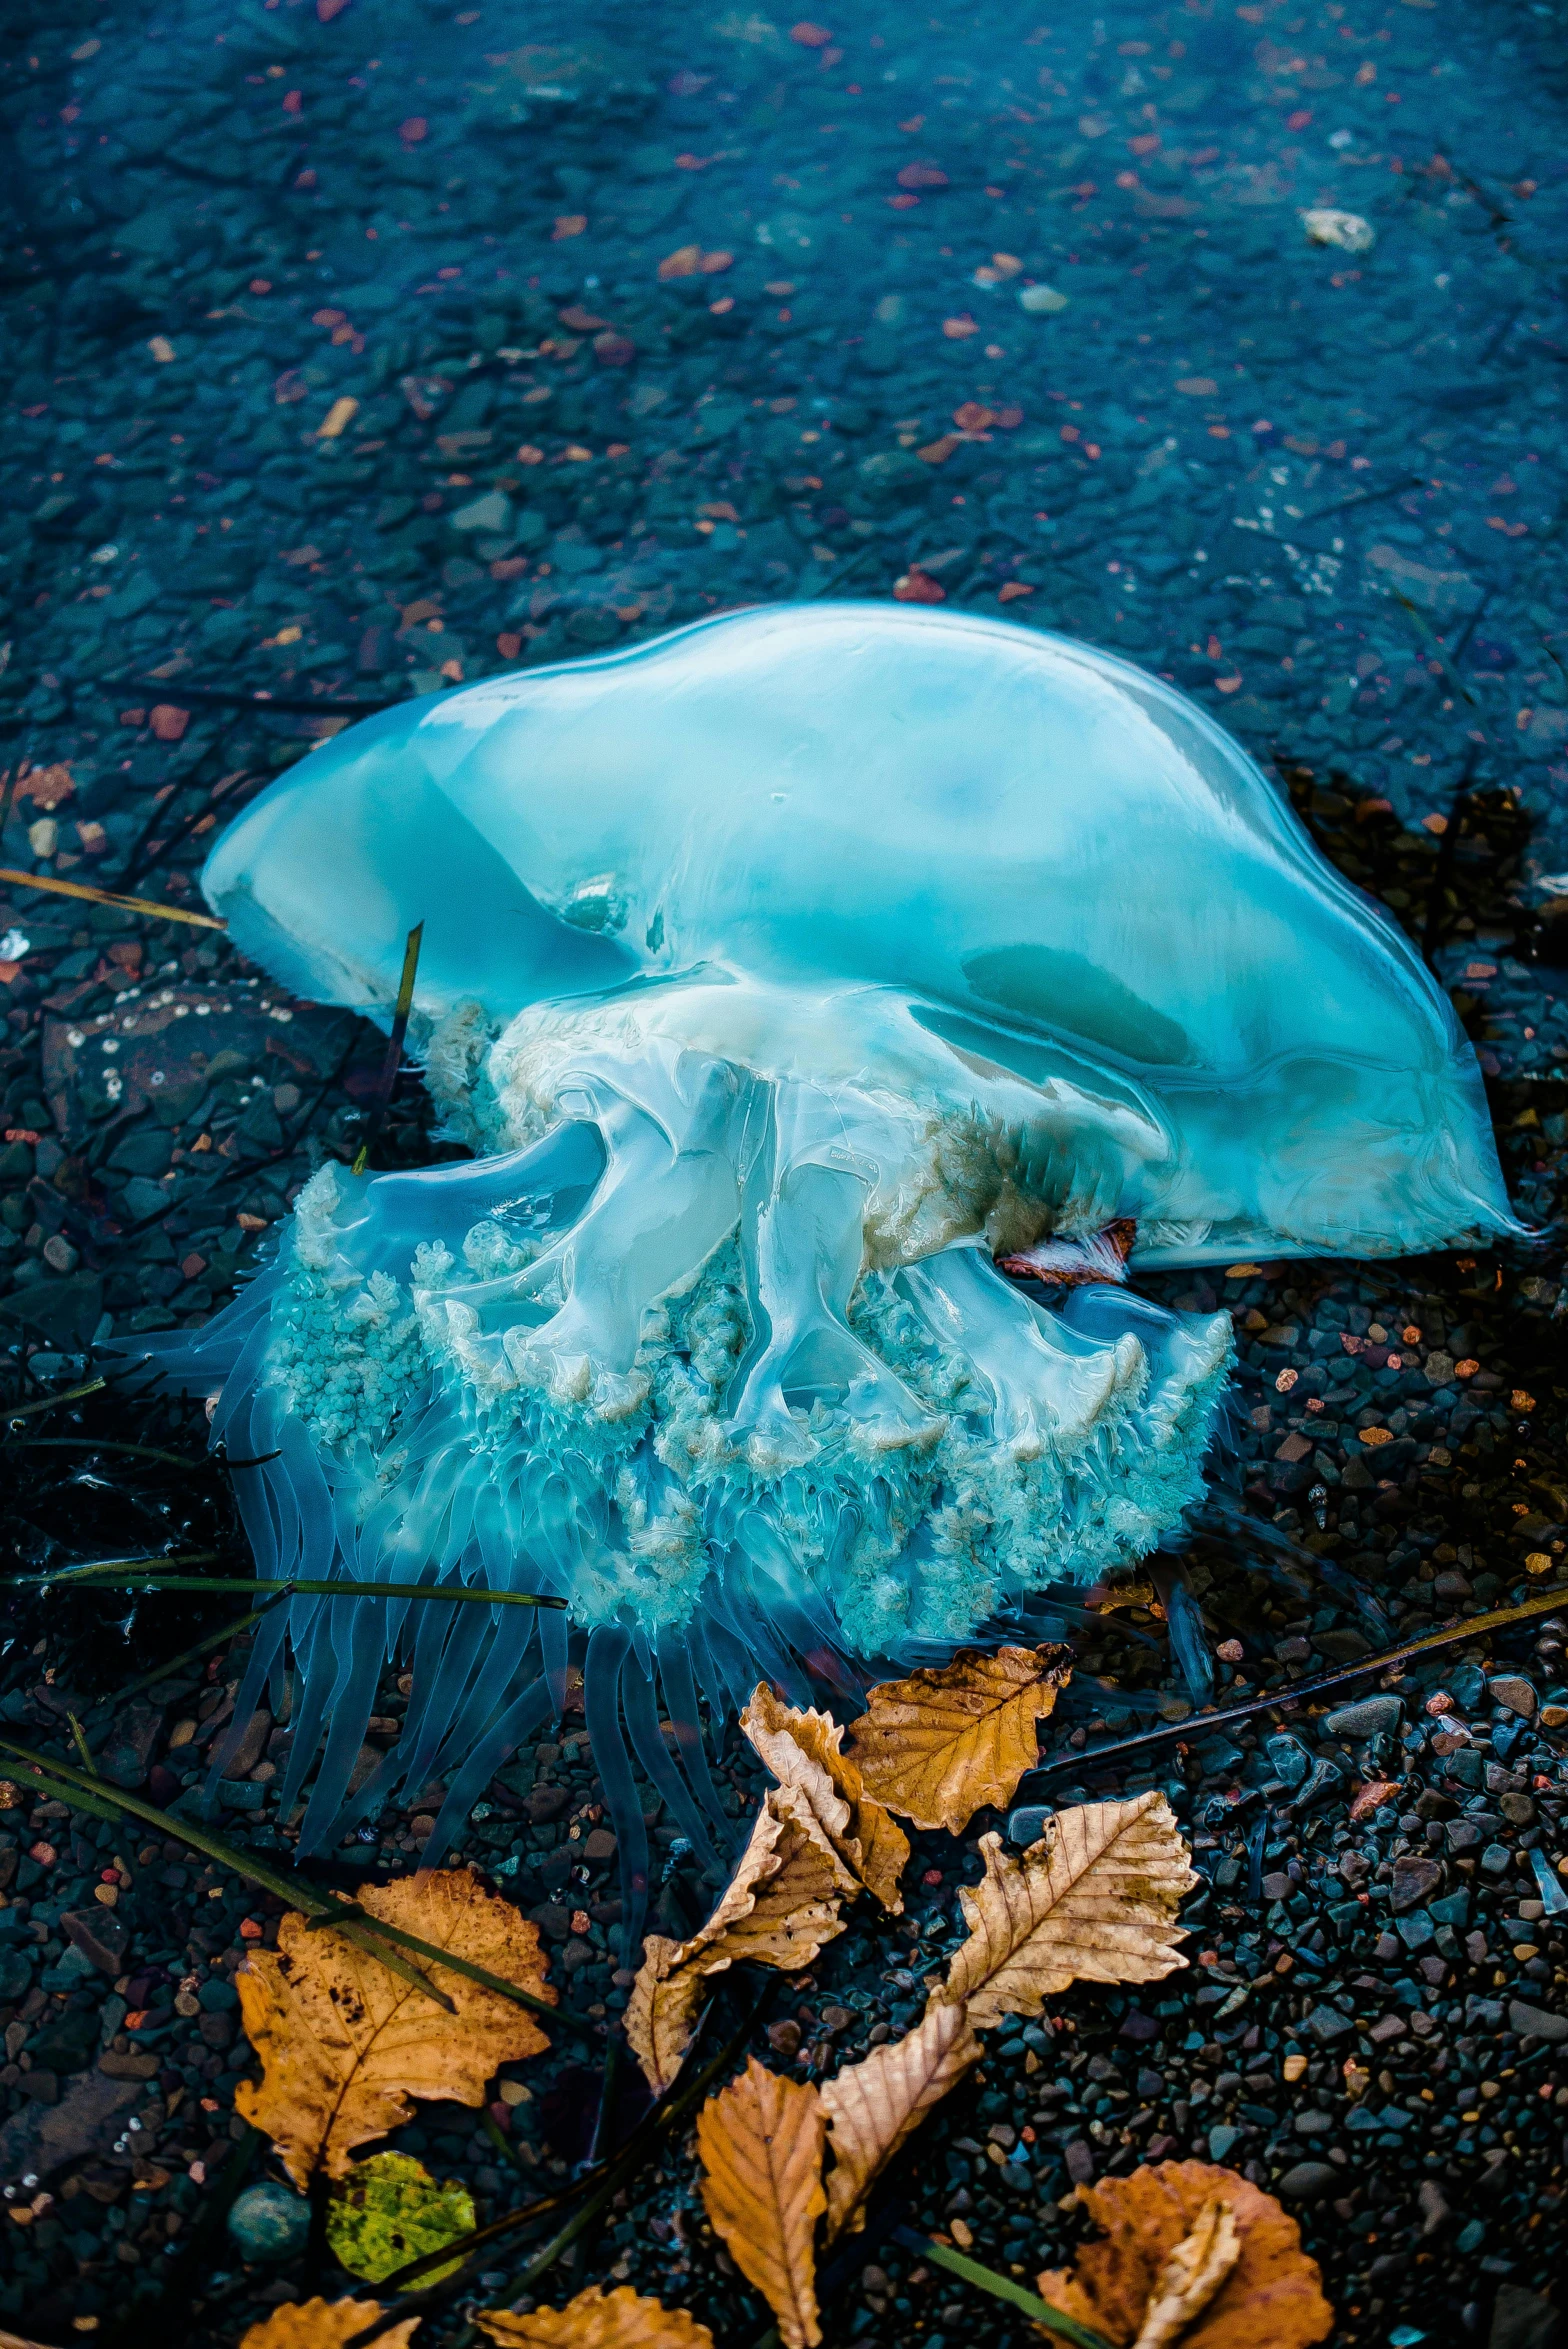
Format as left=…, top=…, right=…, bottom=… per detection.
left=1038, top=2161, right=1333, bottom=2349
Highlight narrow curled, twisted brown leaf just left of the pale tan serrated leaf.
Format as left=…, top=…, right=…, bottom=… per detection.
left=627, top=1785, right=857, bottom=2095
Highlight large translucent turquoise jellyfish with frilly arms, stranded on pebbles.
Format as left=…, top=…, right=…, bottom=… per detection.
left=116, top=604, right=1519, bottom=1947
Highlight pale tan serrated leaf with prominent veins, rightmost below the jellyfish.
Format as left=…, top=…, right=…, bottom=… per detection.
left=937, top=1792, right=1197, bottom=2032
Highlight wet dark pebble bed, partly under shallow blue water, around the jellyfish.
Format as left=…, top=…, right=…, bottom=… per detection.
left=0, top=0, right=1568, bottom=2349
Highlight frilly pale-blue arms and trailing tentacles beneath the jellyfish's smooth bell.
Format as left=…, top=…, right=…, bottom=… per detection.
left=150, top=977, right=1230, bottom=1944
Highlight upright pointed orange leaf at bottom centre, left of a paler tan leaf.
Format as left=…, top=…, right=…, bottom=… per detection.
left=697, top=2055, right=826, bottom=2349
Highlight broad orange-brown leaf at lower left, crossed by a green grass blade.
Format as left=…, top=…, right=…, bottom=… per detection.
left=235, top=1867, right=554, bottom=2187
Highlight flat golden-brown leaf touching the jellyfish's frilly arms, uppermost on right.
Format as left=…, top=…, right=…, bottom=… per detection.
left=850, top=1647, right=1073, bottom=1835
